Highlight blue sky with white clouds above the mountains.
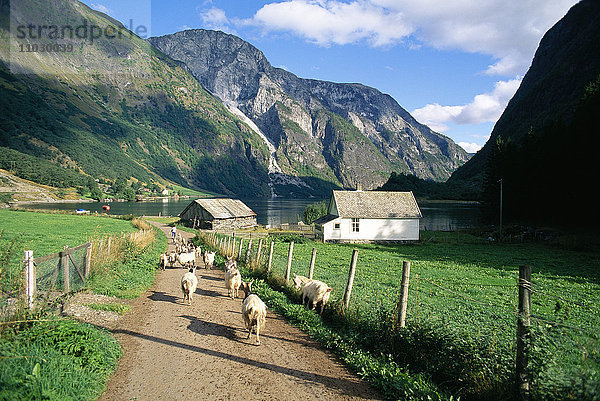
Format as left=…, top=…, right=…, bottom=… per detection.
left=83, top=0, right=577, bottom=153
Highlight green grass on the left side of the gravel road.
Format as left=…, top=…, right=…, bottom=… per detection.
left=0, top=210, right=167, bottom=400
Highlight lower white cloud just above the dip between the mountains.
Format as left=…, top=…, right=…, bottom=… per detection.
left=411, top=78, right=521, bottom=128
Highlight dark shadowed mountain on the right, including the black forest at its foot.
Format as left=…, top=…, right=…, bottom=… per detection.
left=448, top=0, right=600, bottom=226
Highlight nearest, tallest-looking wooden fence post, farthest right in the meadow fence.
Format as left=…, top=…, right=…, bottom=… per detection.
left=516, top=265, right=531, bottom=400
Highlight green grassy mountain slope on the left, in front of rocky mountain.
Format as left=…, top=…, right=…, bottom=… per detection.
left=0, top=0, right=270, bottom=196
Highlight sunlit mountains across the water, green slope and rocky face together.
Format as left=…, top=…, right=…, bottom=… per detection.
left=0, top=0, right=468, bottom=197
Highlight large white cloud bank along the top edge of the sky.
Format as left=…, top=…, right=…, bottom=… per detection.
left=245, top=0, right=577, bottom=76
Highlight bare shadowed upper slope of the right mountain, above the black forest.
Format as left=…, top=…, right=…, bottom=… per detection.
left=449, top=0, right=600, bottom=186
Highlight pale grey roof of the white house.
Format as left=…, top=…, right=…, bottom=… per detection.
left=332, top=191, right=423, bottom=219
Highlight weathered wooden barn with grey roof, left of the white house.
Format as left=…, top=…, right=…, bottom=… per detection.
left=179, top=198, right=257, bottom=230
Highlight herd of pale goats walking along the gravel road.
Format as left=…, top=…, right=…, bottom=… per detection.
left=159, top=234, right=333, bottom=345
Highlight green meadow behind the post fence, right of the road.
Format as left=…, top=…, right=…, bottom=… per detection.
left=203, top=232, right=600, bottom=400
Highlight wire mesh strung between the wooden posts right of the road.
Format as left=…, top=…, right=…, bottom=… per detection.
left=203, top=231, right=600, bottom=399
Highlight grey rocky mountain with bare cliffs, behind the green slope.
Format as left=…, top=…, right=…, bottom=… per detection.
left=149, top=29, right=469, bottom=194
